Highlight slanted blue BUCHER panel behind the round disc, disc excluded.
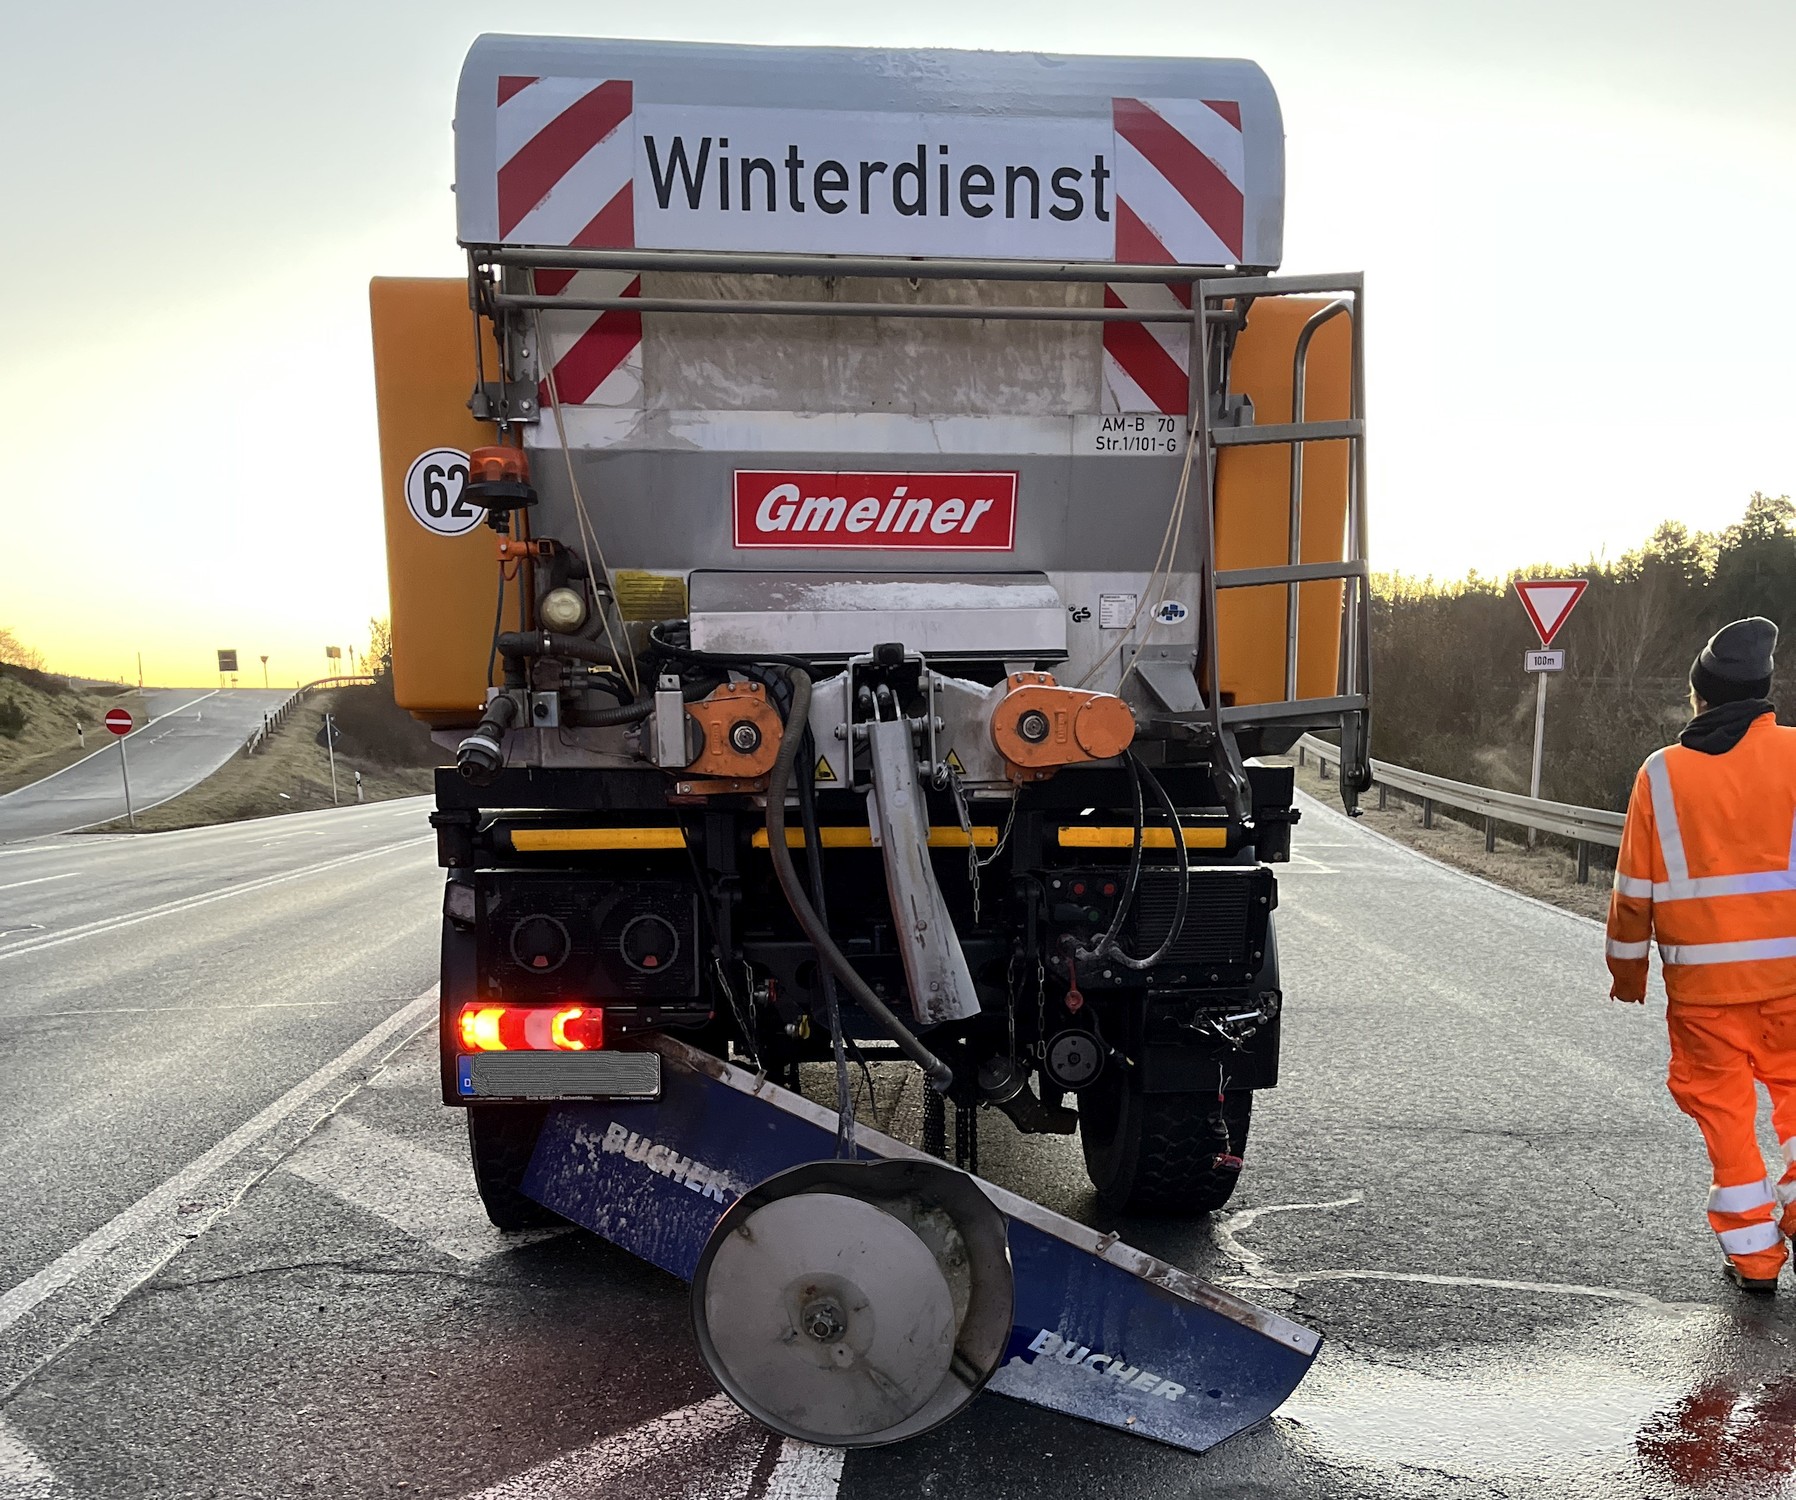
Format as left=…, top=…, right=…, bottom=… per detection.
left=523, top=1037, right=1322, bottom=1453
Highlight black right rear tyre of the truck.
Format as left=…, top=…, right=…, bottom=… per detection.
left=1079, top=1069, right=1254, bottom=1216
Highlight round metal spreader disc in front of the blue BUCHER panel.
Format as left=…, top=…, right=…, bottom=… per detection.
left=691, top=1160, right=1011, bottom=1448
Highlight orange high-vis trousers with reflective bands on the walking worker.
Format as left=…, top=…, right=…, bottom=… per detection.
left=1667, top=995, right=1796, bottom=1279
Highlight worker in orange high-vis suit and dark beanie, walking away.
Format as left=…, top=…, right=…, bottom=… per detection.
left=1609, top=618, right=1796, bottom=1293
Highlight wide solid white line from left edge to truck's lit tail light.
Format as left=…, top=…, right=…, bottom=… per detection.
left=0, top=986, right=436, bottom=1398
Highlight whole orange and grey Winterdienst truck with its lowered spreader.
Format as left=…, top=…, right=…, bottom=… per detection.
left=374, top=38, right=1370, bottom=1450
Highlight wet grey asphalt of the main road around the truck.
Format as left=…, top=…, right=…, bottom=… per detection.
left=0, top=790, right=1796, bottom=1500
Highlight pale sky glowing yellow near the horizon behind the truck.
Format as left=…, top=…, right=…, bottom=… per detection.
left=0, top=0, right=1796, bottom=684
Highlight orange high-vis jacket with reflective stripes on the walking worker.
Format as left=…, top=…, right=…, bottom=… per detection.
left=1607, top=711, right=1796, bottom=1006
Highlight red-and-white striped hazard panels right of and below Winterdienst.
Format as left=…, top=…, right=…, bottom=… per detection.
left=1105, top=99, right=1246, bottom=413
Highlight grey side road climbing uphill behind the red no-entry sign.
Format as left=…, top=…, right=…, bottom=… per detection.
left=0, top=688, right=293, bottom=844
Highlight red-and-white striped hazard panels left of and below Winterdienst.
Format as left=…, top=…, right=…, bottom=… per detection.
left=497, top=77, right=643, bottom=408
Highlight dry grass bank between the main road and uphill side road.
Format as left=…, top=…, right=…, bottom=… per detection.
left=88, top=688, right=431, bottom=834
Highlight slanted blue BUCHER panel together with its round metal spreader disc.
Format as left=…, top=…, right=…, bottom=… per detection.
left=523, top=1037, right=1322, bottom=1453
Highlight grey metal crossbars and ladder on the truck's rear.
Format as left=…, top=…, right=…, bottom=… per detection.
left=467, top=246, right=1372, bottom=798
